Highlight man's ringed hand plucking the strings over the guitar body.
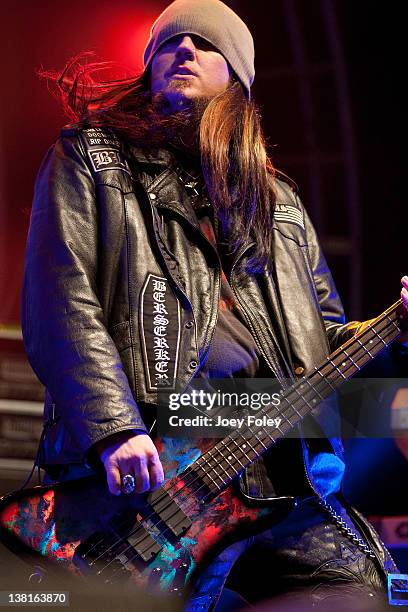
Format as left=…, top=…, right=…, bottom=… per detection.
left=95, top=430, right=164, bottom=495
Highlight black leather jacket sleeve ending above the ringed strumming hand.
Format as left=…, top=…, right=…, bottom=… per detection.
left=21, top=136, right=146, bottom=458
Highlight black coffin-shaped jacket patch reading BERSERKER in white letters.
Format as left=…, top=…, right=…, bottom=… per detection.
left=140, top=274, right=180, bottom=391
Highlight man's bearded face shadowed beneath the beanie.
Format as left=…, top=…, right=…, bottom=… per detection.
left=151, top=34, right=230, bottom=112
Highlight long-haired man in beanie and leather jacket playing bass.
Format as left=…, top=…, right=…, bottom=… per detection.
left=22, top=0, right=408, bottom=609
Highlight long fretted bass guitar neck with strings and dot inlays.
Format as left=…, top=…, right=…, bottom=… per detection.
left=194, top=300, right=407, bottom=494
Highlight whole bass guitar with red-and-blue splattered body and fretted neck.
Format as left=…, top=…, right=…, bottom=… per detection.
left=0, top=300, right=407, bottom=592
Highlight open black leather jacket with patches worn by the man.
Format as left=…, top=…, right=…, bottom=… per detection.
left=22, top=126, right=364, bottom=498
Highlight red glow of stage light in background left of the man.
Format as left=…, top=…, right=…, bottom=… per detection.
left=0, top=0, right=170, bottom=325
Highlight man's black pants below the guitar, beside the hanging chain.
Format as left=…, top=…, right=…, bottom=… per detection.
left=191, top=496, right=398, bottom=612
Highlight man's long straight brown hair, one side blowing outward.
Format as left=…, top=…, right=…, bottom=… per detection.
left=40, top=53, right=276, bottom=271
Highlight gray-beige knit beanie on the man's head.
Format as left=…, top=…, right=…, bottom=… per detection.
left=143, top=0, right=255, bottom=99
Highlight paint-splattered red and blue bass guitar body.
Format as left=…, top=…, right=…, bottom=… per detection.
left=0, top=438, right=278, bottom=592
